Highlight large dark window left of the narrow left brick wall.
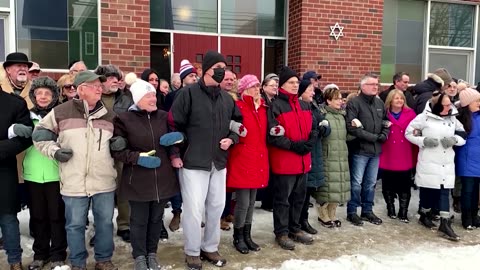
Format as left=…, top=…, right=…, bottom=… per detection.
left=15, top=0, right=99, bottom=69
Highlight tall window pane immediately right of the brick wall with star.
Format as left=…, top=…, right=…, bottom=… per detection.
left=380, top=0, right=426, bottom=83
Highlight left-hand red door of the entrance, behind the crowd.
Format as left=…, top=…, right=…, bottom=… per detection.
left=172, top=34, right=218, bottom=73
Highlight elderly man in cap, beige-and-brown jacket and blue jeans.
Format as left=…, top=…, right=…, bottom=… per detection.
left=32, top=71, right=121, bottom=270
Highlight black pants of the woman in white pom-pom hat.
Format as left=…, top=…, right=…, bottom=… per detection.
left=128, top=198, right=169, bottom=258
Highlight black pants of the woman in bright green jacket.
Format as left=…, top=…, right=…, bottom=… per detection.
left=25, top=181, right=67, bottom=262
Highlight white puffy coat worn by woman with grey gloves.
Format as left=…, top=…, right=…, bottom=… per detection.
left=405, top=103, right=465, bottom=189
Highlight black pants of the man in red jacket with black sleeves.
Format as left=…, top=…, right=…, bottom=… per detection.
left=270, top=174, right=306, bottom=236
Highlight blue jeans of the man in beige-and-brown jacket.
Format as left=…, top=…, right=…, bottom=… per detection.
left=63, top=191, right=115, bottom=267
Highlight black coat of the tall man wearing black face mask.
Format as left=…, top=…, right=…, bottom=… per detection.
left=168, top=80, right=243, bottom=171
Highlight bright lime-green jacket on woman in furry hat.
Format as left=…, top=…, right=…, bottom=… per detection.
left=23, top=116, right=60, bottom=184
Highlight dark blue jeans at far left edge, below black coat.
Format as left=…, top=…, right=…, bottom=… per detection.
left=0, top=214, right=23, bottom=264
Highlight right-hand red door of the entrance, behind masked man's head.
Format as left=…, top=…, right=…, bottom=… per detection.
left=220, top=37, right=262, bottom=81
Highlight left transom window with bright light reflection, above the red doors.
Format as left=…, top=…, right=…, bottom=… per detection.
left=150, top=0, right=218, bottom=33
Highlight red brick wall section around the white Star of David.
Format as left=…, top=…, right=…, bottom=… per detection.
left=288, top=0, right=383, bottom=91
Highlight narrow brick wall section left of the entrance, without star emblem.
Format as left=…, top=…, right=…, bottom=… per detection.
left=101, top=0, right=150, bottom=75
